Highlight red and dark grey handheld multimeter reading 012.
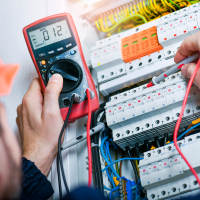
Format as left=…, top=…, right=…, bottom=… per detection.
left=23, top=13, right=99, bottom=121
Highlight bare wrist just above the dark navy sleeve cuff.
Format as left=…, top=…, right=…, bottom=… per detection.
left=22, top=145, right=56, bottom=176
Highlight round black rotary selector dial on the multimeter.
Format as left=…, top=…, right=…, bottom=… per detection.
left=47, top=59, right=83, bottom=93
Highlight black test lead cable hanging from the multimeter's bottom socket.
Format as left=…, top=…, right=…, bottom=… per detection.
left=57, top=94, right=74, bottom=199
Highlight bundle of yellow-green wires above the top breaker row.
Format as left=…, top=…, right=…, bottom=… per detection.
left=95, top=0, right=199, bottom=36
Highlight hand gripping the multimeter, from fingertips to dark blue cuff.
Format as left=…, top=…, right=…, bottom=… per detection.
left=16, top=74, right=63, bottom=176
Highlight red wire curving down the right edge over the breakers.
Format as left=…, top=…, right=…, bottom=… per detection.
left=173, top=59, right=200, bottom=185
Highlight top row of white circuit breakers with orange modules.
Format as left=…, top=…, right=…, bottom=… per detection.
left=91, top=3, right=200, bottom=96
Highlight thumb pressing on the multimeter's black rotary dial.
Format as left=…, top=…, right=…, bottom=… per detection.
left=43, top=74, right=63, bottom=114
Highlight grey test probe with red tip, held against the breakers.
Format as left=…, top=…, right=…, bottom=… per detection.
left=147, top=53, right=199, bottom=87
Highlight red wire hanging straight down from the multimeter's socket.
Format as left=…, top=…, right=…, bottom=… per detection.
left=86, top=89, right=92, bottom=187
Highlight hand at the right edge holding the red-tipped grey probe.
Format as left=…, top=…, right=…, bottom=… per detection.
left=174, top=32, right=200, bottom=88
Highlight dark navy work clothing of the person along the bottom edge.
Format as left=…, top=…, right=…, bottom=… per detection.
left=21, top=158, right=106, bottom=200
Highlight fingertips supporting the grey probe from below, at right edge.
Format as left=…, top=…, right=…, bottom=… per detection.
left=181, top=63, right=200, bottom=88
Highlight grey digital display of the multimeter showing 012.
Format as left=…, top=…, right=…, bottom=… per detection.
left=29, top=20, right=72, bottom=50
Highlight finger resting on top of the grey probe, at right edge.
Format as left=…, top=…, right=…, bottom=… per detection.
left=174, top=32, right=200, bottom=63
